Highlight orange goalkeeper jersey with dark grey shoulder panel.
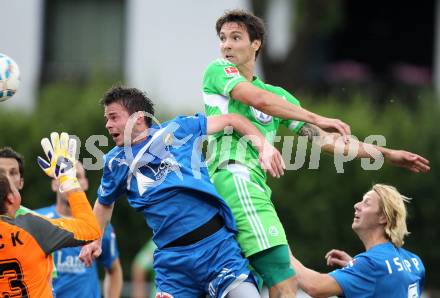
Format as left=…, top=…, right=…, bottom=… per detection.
left=0, top=192, right=101, bottom=298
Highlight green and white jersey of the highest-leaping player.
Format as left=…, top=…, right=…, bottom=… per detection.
left=203, top=59, right=304, bottom=177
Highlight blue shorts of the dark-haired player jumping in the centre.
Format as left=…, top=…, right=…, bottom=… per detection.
left=154, top=228, right=256, bottom=298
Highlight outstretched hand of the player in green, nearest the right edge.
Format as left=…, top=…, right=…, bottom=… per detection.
left=386, top=150, right=431, bottom=173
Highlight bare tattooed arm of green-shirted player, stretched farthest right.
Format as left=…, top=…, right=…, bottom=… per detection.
left=299, top=123, right=430, bottom=173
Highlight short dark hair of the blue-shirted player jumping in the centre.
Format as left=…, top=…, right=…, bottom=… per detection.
left=100, top=86, right=154, bottom=127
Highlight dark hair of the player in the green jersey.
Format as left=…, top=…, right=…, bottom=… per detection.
left=215, top=9, right=266, bottom=58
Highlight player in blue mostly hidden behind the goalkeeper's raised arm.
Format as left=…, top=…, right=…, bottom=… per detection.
left=36, top=162, right=123, bottom=298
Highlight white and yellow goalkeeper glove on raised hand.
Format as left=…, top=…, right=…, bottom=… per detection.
left=37, top=132, right=81, bottom=192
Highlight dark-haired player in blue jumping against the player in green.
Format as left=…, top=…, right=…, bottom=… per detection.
left=81, top=87, right=283, bottom=298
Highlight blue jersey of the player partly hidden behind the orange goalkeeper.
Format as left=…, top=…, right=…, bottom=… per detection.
left=36, top=205, right=119, bottom=298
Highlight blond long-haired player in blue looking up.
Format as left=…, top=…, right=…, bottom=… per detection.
left=293, top=184, right=425, bottom=298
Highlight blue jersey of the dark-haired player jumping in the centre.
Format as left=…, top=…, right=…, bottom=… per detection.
left=98, top=114, right=235, bottom=248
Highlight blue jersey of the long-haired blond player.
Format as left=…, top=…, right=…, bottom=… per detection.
left=330, top=242, right=425, bottom=298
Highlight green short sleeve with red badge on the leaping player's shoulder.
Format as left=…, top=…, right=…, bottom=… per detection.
left=203, top=59, right=247, bottom=98
